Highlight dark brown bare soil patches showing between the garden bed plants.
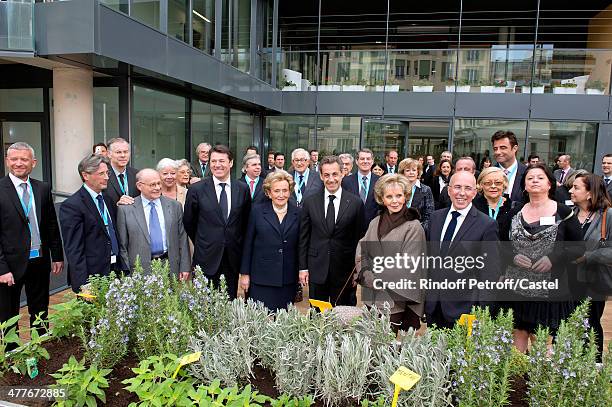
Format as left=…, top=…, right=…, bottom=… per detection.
left=0, top=337, right=528, bottom=407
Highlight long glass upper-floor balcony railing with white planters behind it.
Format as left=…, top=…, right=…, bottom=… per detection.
left=277, top=47, right=612, bottom=95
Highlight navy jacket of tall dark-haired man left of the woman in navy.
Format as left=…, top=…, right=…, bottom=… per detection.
left=183, top=177, right=251, bottom=276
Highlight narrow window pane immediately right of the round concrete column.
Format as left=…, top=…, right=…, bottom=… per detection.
left=94, top=88, right=120, bottom=143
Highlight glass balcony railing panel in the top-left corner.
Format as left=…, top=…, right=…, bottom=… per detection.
left=0, top=0, right=34, bottom=52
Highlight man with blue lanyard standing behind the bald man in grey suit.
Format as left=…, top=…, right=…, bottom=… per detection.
left=105, top=137, right=140, bottom=206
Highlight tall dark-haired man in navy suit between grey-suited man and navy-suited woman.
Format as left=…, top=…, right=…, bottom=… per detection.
left=183, top=145, right=251, bottom=299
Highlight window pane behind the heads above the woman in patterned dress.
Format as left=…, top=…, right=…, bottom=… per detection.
left=529, top=121, right=597, bottom=171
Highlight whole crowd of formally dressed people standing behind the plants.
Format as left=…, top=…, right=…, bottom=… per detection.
left=0, top=131, right=612, bottom=360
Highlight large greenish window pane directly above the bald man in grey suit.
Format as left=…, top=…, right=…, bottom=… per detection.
left=132, top=86, right=187, bottom=168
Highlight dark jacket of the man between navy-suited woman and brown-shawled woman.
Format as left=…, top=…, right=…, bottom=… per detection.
left=299, top=190, right=365, bottom=285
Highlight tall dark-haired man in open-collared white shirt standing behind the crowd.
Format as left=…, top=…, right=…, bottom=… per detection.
left=491, top=130, right=527, bottom=204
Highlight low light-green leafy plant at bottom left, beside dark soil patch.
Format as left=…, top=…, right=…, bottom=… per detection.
left=51, top=356, right=111, bottom=407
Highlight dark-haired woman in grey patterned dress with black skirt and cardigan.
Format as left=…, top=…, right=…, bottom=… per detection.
left=500, top=164, right=583, bottom=352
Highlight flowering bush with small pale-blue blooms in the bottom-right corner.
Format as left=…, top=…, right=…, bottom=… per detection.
left=527, top=301, right=612, bottom=407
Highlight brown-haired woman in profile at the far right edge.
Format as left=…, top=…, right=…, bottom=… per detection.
left=570, top=174, right=612, bottom=362
